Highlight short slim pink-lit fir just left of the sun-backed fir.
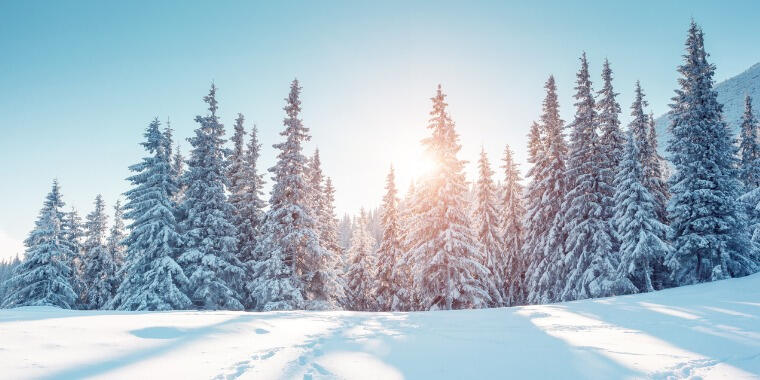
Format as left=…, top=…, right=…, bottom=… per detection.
left=377, top=166, right=411, bottom=311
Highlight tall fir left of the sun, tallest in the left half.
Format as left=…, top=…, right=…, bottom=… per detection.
left=254, top=80, right=337, bottom=310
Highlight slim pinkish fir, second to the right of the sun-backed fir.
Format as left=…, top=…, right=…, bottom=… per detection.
left=499, top=145, right=528, bottom=306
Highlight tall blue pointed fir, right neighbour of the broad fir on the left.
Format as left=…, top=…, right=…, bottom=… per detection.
left=179, top=84, right=245, bottom=310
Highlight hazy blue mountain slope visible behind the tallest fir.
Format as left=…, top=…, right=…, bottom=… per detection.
left=656, top=63, right=760, bottom=155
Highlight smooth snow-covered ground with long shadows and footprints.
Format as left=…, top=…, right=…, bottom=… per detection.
left=0, top=275, right=760, bottom=379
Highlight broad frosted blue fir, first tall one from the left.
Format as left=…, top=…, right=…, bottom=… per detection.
left=107, top=119, right=191, bottom=310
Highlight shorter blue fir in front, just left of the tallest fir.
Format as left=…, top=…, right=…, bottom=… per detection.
left=613, top=133, right=670, bottom=292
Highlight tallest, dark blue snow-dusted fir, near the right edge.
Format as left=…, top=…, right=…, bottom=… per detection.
left=665, top=21, right=758, bottom=285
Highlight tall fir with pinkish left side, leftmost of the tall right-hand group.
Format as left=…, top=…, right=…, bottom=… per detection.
left=523, top=76, right=567, bottom=304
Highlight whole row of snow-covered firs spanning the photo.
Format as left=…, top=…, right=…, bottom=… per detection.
left=2, top=22, right=760, bottom=311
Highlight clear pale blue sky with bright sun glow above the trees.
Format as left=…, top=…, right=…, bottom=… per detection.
left=0, top=1, right=760, bottom=258
